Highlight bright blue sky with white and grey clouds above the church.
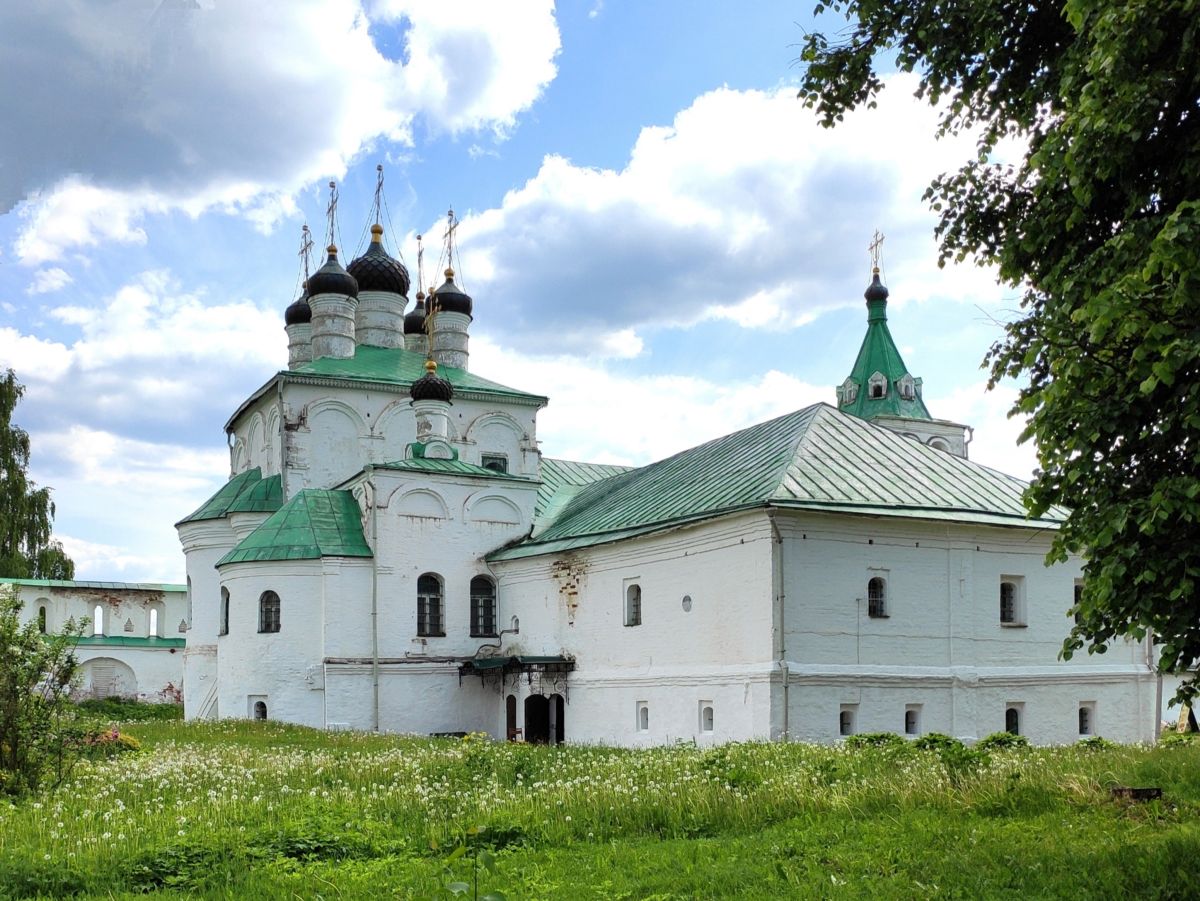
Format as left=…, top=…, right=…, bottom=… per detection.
left=0, top=0, right=1034, bottom=581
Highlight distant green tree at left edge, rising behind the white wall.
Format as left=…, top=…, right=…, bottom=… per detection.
left=0, top=370, right=74, bottom=578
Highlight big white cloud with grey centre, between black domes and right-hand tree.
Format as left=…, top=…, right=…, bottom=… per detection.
left=426, top=76, right=998, bottom=352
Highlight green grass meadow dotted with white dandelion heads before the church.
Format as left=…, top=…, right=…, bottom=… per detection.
left=0, top=721, right=1200, bottom=900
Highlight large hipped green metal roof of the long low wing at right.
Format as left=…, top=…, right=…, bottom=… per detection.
left=490, top=404, right=1063, bottom=559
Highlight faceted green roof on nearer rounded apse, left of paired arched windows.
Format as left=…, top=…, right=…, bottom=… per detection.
left=217, top=488, right=372, bottom=566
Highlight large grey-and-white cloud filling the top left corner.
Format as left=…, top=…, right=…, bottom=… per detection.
left=7, top=0, right=559, bottom=265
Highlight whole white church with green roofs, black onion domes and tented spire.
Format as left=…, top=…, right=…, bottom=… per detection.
left=178, top=226, right=1158, bottom=745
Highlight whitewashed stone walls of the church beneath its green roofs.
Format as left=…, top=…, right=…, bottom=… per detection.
left=179, top=259, right=1158, bottom=745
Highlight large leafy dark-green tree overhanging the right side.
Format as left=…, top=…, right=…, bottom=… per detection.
left=800, top=0, right=1200, bottom=693
